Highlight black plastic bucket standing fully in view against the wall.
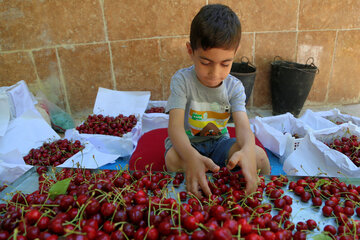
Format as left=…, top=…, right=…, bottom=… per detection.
left=271, top=58, right=318, bottom=117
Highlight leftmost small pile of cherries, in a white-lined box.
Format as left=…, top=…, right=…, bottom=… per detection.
left=23, top=138, right=85, bottom=167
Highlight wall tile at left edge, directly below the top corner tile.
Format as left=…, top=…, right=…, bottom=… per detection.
left=0, top=52, right=37, bottom=90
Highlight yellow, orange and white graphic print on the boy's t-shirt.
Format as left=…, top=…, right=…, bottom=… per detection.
left=187, top=101, right=230, bottom=136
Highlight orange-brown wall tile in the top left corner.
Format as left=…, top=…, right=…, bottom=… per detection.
left=0, top=0, right=105, bottom=51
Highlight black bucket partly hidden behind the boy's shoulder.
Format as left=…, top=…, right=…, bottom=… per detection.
left=230, top=57, right=256, bottom=104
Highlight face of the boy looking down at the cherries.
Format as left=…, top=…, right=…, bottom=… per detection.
left=186, top=42, right=236, bottom=88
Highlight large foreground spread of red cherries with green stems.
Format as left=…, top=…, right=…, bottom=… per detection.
left=0, top=167, right=360, bottom=240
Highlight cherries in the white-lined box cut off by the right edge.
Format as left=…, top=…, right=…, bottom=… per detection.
left=326, top=135, right=360, bottom=167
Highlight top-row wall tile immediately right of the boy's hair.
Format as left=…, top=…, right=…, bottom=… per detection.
left=209, top=0, right=299, bottom=32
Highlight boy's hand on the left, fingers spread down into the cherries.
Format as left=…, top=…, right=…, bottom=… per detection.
left=184, top=153, right=220, bottom=199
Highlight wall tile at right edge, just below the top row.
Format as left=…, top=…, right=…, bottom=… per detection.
left=328, top=30, right=360, bottom=104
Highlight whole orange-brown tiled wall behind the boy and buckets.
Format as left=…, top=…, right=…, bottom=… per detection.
left=0, top=0, right=360, bottom=114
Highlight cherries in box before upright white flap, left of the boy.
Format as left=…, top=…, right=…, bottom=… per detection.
left=76, top=114, right=137, bottom=137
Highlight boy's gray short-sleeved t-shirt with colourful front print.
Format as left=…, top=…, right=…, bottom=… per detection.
left=166, top=66, right=246, bottom=142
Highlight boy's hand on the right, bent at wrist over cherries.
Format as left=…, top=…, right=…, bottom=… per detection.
left=226, top=150, right=258, bottom=194
